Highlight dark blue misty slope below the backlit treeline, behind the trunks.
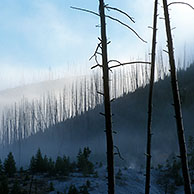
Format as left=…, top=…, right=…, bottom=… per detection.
left=2, top=66, right=194, bottom=166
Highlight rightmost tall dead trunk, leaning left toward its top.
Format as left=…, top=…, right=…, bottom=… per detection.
left=163, top=0, right=192, bottom=194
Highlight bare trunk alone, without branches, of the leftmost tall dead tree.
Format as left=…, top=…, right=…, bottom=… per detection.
left=99, top=0, right=114, bottom=194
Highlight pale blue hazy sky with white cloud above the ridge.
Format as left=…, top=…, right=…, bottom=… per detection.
left=0, top=0, right=194, bottom=90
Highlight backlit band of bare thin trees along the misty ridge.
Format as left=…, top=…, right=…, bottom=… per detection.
left=0, top=60, right=167, bottom=145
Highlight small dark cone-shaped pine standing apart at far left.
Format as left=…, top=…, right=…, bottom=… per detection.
left=4, top=152, right=16, bottom=177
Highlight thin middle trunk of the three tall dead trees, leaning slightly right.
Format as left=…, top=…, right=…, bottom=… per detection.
left=145, top=0, right=158, bottom=194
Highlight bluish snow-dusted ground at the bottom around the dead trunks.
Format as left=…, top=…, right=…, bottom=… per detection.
left=5, top=166, right=167, bottom=194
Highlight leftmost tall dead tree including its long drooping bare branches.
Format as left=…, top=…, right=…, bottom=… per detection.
left=71, top=0, right=150, bottom=194
